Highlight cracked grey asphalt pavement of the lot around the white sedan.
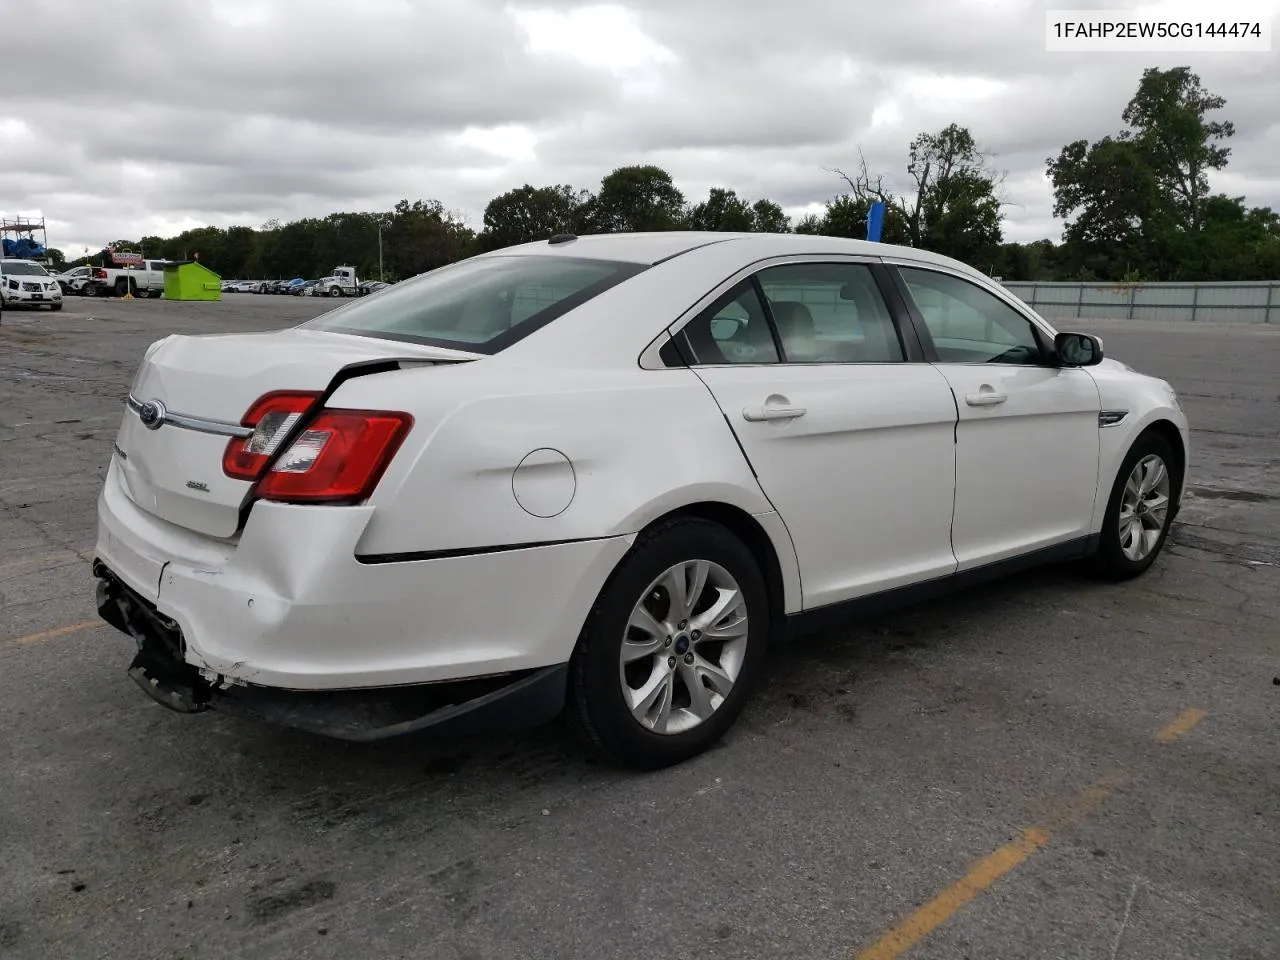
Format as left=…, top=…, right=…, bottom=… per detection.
left=0, top=294, right=1280, bottom=960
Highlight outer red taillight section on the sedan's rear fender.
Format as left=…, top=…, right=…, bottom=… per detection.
left=256, top=410, right=413, bottom=503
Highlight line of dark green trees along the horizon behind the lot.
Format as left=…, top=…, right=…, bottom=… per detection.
left=62, top=67, right=1280, bottom=282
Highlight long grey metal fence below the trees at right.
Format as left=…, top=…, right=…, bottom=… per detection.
left=1005, top=280, right=1280, bottom=324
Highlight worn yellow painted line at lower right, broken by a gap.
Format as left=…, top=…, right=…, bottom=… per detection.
left=854, top=708, right=1208, bottom=960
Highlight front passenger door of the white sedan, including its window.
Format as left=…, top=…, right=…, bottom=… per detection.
left=896, top=264, right=1101, bottom=570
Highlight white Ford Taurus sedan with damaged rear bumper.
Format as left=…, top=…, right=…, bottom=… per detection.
left=95, top=233, right=1188, bottom=767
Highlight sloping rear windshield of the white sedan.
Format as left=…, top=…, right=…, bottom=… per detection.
left=295, top=256, right=645, bottom=353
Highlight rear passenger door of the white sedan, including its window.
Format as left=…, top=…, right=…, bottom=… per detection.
left=676, top=257, right=956, bottom=609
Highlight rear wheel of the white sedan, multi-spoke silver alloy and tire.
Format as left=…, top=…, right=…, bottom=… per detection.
left=570, top=518, right=769, bottom=769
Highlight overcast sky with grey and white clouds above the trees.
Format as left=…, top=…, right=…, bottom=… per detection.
left=0, top=0, right=1280, bottom=256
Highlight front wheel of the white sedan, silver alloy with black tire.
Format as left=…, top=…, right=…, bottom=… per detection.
left=1093, top=433, right=1183, bottom=581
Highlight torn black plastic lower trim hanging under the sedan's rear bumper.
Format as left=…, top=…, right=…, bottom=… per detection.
left=93, top=561, right=568, bottom=741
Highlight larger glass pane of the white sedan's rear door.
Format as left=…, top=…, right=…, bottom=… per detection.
left=758, top=264, right=906, bottom=364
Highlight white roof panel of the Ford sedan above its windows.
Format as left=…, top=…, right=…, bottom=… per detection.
left=481, top=230, right=972, bottom=271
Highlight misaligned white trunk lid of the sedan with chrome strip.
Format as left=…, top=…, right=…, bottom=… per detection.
left=114, top=329, right=477, bottom=538
